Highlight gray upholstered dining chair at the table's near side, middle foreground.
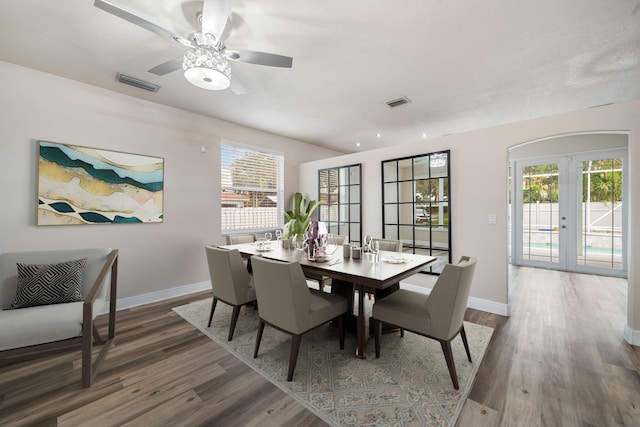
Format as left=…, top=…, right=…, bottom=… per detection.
left=251, top=256, right=347, bottom=381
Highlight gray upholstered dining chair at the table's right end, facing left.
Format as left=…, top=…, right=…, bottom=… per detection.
left=372, top=256, right=476, bottom=389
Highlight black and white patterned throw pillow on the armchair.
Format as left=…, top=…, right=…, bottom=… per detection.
left=9, top=258, right=87, bottom=310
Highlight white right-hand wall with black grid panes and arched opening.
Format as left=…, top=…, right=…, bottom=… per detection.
left=299, top=101, right=640, bottom=331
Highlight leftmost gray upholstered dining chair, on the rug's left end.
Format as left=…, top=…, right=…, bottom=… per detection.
left=205, top=246, right=256, bottom=341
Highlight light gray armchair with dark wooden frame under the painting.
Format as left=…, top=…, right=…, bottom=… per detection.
left=0, top=248, right=118, bottom=387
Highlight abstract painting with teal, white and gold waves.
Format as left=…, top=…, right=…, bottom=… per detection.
left=37, top=141, right=164, bottom=225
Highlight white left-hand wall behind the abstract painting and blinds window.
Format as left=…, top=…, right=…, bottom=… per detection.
left=0, top=62, right=338, bottom=298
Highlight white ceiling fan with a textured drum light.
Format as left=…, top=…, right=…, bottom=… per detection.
left=93, top=0, right=293, bottom=95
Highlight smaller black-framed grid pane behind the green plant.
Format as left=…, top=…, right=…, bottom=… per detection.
left=318, top=164, right=362, bottom=243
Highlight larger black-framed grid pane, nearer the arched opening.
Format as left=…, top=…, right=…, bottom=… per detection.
left=382, top=150, right=451, bottom=274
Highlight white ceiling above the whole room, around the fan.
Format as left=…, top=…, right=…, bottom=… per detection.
left=0, top=0, right=640, bottom=153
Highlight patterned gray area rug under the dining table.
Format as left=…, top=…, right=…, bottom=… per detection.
left=174, top=300, right=493, bottom=426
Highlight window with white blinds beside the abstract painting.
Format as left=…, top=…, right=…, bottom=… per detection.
left=220, top=141, right=284, bottom=234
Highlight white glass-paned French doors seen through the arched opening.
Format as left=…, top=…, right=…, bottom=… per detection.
left=511, top=150, right=627, bottom=276
